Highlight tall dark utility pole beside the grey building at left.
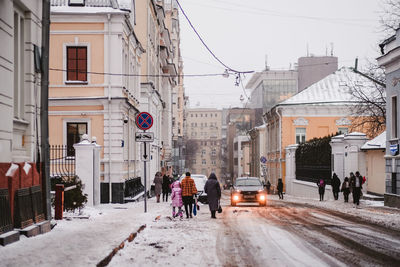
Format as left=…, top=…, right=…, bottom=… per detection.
left=40, top=0, right=51, bottom=220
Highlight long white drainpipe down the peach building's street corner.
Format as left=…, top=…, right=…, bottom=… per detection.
left=107, top=14, right=112, bottom=203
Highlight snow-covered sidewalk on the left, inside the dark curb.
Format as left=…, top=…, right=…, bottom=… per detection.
left=0, top=198, right=171, bottom=266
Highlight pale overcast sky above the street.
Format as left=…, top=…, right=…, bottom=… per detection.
left=179, top=0, right=383, bottom=108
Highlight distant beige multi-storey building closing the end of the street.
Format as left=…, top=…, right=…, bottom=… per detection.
left=186, top=108, right=222, bottom=178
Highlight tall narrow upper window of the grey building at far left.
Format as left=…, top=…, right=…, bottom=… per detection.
left=14, top=10, right=25, bottom=119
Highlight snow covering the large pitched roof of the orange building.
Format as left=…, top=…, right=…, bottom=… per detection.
left=277, top=67, right=377, bottom=106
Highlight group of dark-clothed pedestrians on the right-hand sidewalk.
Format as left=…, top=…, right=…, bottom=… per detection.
left=317, top=171, right=365, bottom=206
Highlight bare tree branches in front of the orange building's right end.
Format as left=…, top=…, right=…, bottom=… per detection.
left=347, top=64, right=386, bottom=138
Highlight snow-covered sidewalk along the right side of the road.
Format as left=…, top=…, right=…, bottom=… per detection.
left=280, top=195, right=400, bottom=230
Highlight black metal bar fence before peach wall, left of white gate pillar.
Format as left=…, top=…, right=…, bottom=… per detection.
left=50, top=145, right=75, bottom=177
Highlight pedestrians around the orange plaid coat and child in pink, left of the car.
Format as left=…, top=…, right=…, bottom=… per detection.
left=154, top=172, right=221, bottom=219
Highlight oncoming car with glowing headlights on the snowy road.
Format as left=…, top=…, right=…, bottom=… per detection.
left=231, top=177, right=267, bottom=206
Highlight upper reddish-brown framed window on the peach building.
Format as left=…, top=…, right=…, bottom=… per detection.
left=67, top=46, right=87, bottom=82
